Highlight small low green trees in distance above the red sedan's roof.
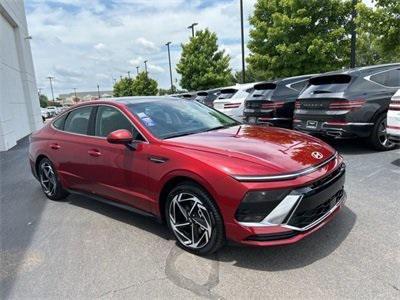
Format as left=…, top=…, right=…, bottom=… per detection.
left=113, top=72, right=158, bottom=97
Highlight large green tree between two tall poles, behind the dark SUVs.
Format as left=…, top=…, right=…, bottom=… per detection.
left=247, top=0, right=351, bottom=80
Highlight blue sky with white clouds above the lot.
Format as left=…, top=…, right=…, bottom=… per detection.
left=25, top=0, right=256, bottom=96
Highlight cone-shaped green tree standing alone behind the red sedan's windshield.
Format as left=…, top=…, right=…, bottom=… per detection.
left=176, top=29, right=233, bottom=91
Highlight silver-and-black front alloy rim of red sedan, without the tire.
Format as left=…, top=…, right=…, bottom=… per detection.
left=169, top=193, right=213, bottom=249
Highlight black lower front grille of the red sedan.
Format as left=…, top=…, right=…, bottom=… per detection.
left=289, top=189, right=344, bottom=228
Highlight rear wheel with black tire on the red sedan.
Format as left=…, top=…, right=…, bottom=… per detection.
left=37, top=158, right=68, bottom=201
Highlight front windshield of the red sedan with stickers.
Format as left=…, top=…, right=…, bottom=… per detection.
left=127, top=99, right=239, bottom=139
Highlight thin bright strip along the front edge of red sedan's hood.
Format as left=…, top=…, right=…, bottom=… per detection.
left=232, top=151, right=338, bottom=182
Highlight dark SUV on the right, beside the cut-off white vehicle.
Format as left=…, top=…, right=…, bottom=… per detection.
left=293, top=63, right=400, bottom=150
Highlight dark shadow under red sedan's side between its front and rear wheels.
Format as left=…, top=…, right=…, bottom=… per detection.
left=66, top=195, right=172, bottom=240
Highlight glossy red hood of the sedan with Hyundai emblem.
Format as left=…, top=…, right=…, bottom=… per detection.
left=166, top=125, right=336, bottom=175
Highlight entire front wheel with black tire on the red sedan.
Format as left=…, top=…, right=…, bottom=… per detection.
left=165, top=182, right=225, bottom=255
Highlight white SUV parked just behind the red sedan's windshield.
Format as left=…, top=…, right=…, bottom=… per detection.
left=213, top=83, right=255, bottom=122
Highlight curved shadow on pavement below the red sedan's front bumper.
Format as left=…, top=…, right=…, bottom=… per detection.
left=216, top=207, right=357, bottom=272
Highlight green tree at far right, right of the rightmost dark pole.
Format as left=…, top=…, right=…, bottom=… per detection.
left=356, top=0, right=400, bottom=65
